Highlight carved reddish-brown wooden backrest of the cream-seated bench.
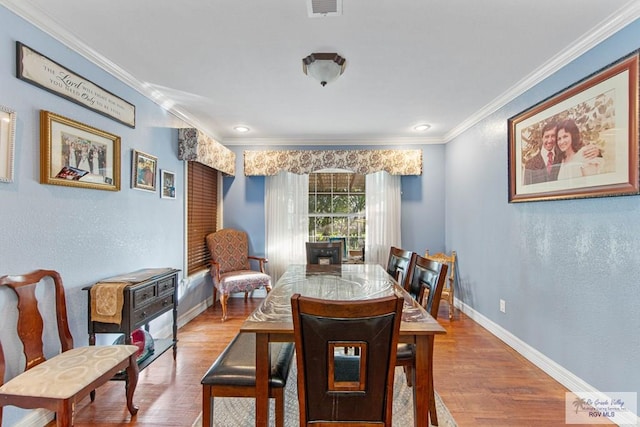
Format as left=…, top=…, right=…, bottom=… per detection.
left=0, top=270, right=73, bottom=378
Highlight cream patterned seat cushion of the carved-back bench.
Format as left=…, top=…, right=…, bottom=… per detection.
left=0, top=345, right=138, bottom=399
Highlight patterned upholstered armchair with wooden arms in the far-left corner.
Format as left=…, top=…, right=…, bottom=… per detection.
left=206, top=228, right=271, bottom=321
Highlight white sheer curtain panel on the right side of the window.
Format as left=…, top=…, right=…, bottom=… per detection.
left=364, top=172, right=402, bottom=267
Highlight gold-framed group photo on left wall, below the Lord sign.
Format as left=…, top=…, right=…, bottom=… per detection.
left=40, top=110, right=121, bottom=191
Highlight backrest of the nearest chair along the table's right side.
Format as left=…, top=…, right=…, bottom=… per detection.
left=408, top=255, right=448, bottom=319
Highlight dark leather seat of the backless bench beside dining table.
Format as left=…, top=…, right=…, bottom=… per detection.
left=201, top=333, right=295, bottom=388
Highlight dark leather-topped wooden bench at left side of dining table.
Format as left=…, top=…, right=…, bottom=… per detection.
left=201, top=333, right=295, bottom=427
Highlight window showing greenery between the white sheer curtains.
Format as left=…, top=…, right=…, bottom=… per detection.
left=309, top=172, right=366, bottom=251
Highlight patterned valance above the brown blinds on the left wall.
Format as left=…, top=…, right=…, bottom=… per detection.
left=178, top=128, right=236, bottom=176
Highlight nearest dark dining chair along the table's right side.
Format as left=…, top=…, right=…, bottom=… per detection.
left=396, top=255, right=448, bottom=425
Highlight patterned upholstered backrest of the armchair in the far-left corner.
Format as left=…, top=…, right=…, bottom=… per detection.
left=207, top=228, right=251, bottom=273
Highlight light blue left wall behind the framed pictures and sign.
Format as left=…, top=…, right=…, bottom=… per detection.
left=0, top=7, right=200, bottom=425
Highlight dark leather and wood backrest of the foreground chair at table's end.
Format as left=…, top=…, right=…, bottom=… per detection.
left=291, top=294, right=403, bottom=427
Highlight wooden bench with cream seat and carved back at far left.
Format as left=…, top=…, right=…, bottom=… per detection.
left=0, top=270, right=138, bottom=427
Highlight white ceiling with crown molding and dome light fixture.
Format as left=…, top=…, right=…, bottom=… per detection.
left=0, top=0, right=640, bottom=145
